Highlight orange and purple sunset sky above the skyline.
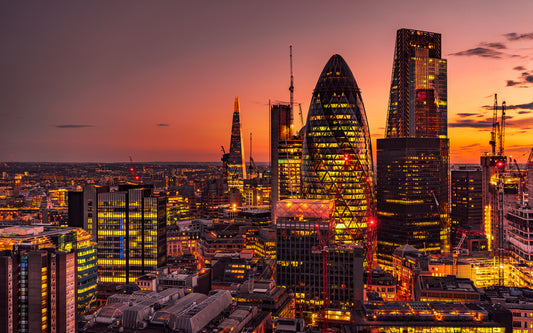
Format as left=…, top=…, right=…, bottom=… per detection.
left=0, top=0, right=533, bottom=163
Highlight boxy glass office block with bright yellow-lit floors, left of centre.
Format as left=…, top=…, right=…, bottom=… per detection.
left=96, top=185, right=167, bottom=284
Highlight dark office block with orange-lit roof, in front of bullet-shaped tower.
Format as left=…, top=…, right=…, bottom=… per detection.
left=276, top=199, right=363, bottom=324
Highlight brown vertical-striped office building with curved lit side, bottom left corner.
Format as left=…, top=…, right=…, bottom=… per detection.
left=0, top=226, right=97, bottom=332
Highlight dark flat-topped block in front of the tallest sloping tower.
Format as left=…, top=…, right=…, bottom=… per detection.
left=377, top=138, right=450, bottom=266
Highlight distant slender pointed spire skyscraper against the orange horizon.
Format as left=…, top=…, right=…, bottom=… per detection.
left=228, top=97, right=246, bottom=189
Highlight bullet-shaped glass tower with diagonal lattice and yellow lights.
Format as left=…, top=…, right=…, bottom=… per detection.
left=302, top=54, right=374, bottom=244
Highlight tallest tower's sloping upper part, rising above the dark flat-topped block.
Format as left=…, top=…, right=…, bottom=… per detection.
left=386, top=29, right=448, bottom=138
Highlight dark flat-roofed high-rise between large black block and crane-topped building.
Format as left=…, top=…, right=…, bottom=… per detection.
left=450, top=165, right=483, bottom=240
